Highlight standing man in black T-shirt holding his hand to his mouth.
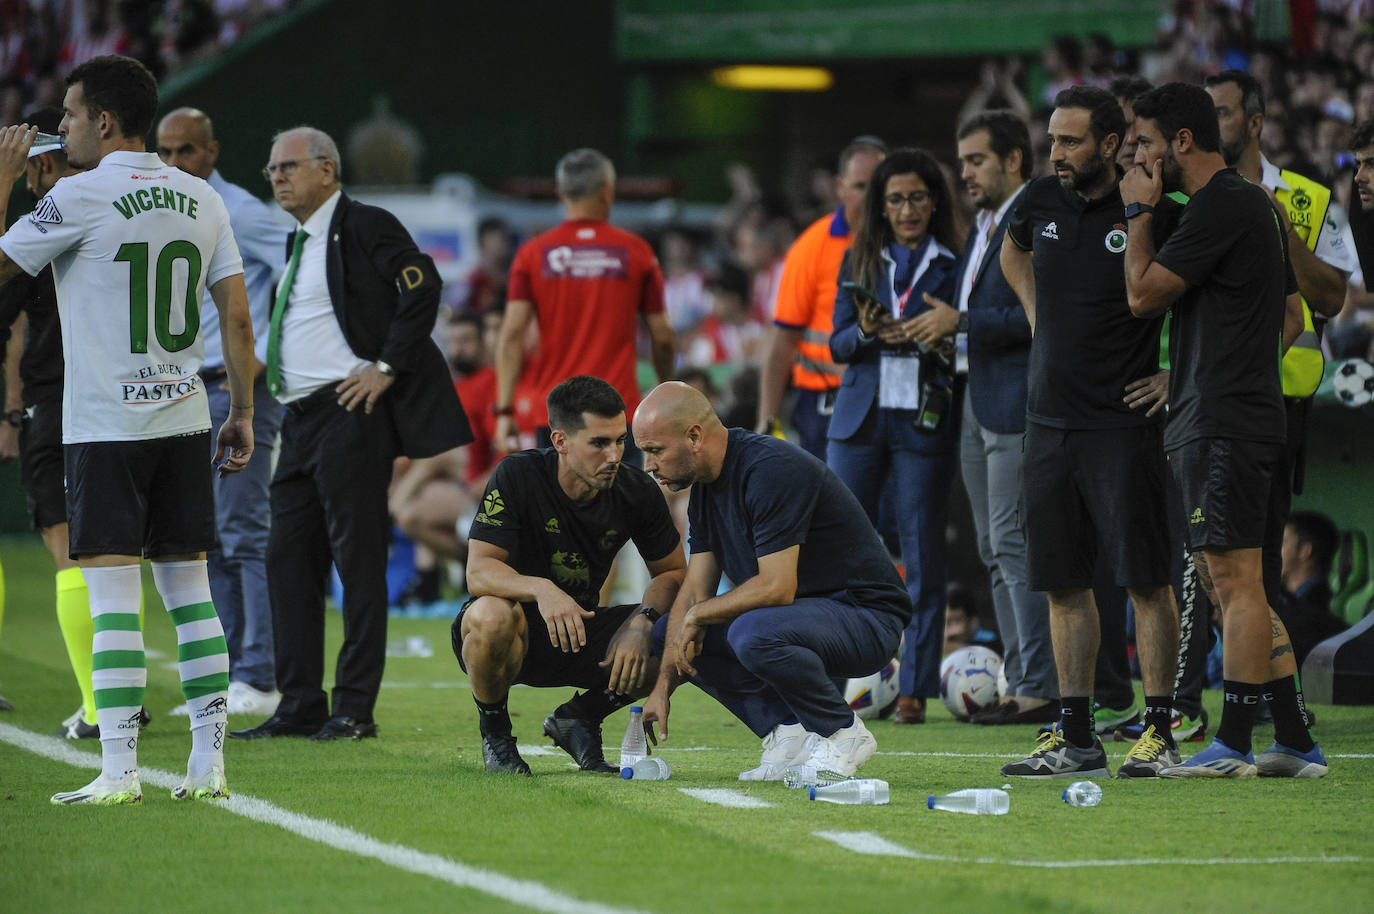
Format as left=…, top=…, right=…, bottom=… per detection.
left=1121, top=82, right=1326, bottom=778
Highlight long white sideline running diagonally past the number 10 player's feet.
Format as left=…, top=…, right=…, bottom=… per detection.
left=0, top=723, right=640, bottom=914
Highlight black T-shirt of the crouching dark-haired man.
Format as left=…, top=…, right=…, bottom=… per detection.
left=469, top=448, right=679, bottom=612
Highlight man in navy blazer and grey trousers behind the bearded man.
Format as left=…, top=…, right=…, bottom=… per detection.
left=919, top=111, right=1058, bottom=723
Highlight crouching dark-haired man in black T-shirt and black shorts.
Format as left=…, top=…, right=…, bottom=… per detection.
left=452, top=375, right=687, bottom=774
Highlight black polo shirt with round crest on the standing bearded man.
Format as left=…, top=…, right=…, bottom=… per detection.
left=1007, top=177, right=1178, bottom=429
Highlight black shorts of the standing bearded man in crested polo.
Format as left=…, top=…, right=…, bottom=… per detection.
left=1022, top=422, right=1171, bottom=591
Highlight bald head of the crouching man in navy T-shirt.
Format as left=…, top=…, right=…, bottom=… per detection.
left=635, top=381, right=730, bottom=492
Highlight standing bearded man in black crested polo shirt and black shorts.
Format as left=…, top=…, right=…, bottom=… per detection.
left=1002, top=85, right=1179, bottom=778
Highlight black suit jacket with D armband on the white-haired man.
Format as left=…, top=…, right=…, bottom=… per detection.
left=286, top=194, right=473, bottom=458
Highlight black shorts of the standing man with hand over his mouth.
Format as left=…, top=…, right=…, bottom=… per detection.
left=1169, top=438, right=1287, bottom=553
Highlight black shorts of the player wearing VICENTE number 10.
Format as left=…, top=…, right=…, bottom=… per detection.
left=63, top=432, right=214, bottom=558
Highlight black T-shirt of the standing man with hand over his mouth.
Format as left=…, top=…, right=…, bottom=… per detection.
left=1156, top=168, right=1297, bottom=449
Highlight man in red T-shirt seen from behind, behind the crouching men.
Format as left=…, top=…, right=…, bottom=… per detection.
left=493, top=148, right=675, bottom=451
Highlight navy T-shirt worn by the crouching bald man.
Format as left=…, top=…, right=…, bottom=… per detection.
left=687, top=429, right=911, bottom=623
